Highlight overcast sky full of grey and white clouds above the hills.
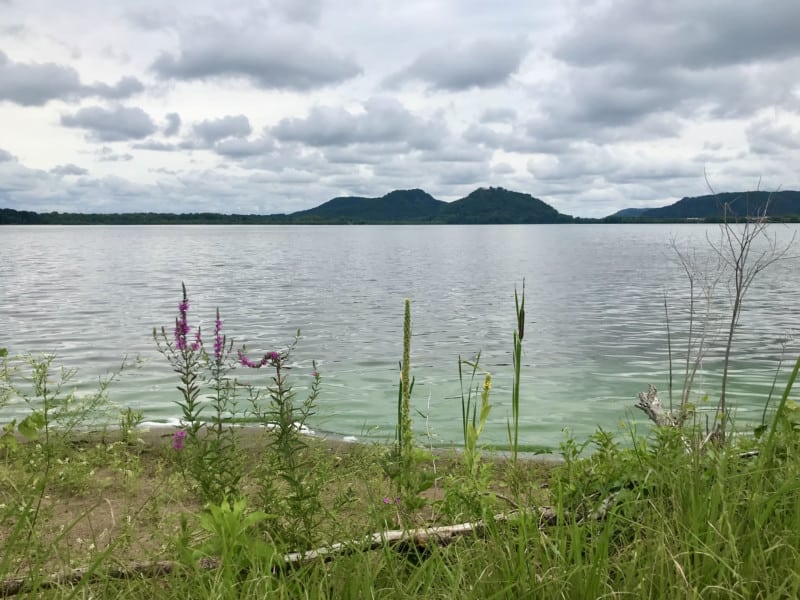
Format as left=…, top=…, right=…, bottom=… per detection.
left=0, top=0, right=800, bottom=216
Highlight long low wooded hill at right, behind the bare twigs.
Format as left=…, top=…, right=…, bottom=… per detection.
left=607, top=191, right=800, bottom=220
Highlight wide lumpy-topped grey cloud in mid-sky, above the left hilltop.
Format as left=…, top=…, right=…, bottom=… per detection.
left=271, top=97, right=446, bottom=148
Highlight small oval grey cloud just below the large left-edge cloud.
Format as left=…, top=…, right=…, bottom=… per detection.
left=61, top=106, right=156, bottom=142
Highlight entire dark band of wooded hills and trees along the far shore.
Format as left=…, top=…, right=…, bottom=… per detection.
left=0, top=187, right=800, bottom=225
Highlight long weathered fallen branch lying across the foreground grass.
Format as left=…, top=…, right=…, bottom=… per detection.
left=0, top=506, right=557, bottom=597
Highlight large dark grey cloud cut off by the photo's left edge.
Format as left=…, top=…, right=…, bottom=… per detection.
left=0, top=52, right=144, bottom=106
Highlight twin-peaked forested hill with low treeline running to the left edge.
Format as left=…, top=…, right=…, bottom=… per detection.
left=0, top=187, right=573, bottom=225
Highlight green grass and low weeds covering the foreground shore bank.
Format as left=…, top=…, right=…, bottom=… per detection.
left=0, top=407, right=800, bottom=598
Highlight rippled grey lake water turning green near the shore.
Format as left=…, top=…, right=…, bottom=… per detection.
left=0, top=225, right=800, bottom=446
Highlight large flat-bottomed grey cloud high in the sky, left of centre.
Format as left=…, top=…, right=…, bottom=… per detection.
left=152, top=21, right=361, bottom=91
